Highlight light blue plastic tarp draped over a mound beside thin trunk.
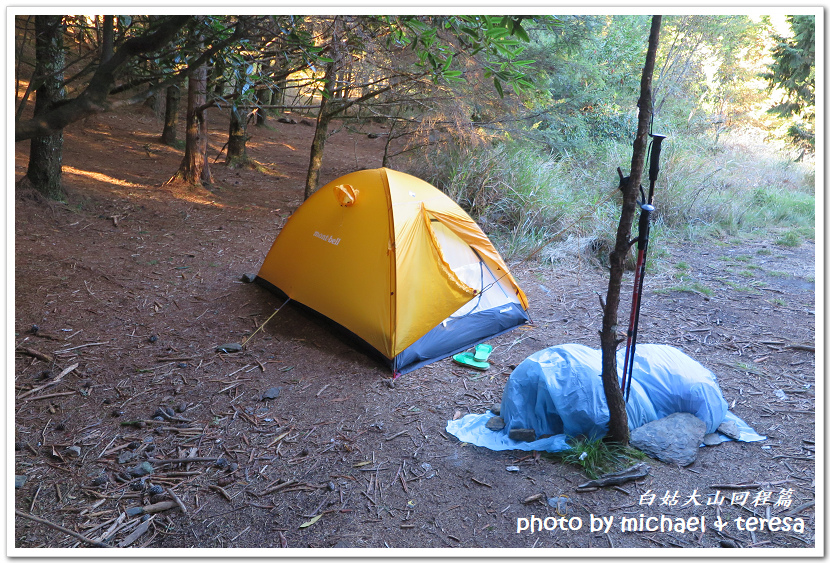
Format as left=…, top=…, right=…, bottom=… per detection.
left=447, top=344, right=766, bottom=452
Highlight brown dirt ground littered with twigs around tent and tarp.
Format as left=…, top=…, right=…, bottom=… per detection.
left=9, top=104, right=821, bottom=554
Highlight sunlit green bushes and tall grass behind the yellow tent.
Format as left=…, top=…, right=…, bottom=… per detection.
left=407, top=16, right=815, bottom=263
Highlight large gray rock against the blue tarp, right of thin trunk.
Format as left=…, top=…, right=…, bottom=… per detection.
left=630, top=412, right=706, bottom=466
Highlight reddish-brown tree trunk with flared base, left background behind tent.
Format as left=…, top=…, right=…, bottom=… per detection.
left=169, top=65, right=210, bottom=184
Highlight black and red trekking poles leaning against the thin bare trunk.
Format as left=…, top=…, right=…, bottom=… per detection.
left=622, top=135, right=666, bottom=401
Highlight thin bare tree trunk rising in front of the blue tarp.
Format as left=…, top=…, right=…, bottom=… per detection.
left=600, top=16, right=662, bottom=445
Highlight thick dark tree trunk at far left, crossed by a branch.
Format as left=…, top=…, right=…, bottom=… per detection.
left=26, top=15, right=65, bottom=199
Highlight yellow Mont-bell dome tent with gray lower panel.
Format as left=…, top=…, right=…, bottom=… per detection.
left=257, top=168, right=529, bottom=373
